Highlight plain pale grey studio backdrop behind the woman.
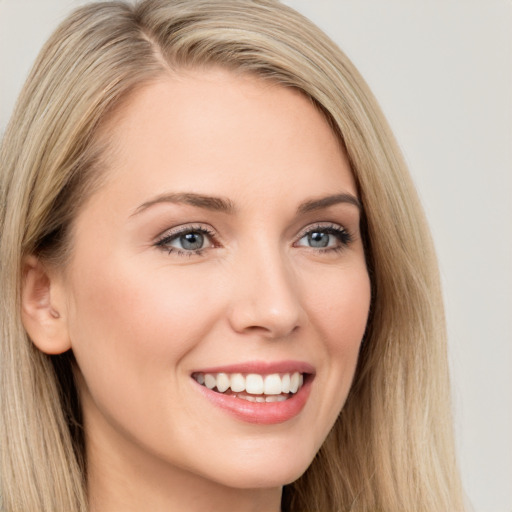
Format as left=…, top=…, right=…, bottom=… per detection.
left=0, top=0, right=512, bottom=512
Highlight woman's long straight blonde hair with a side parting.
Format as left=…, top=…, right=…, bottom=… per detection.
left=0, top=0, right=463, bottom=512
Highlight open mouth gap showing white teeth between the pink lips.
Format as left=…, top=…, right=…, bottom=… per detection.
left=192, top=372, right=308, bottom=403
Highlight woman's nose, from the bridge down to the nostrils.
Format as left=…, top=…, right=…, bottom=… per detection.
left=229, top=245, right=306, bottom=339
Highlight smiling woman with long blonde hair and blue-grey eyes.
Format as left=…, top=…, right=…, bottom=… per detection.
left=0, top=0, right=463, bottom=511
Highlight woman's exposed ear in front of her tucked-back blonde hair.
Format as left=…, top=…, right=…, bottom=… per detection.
left=21, top=256, right=71, bottom=354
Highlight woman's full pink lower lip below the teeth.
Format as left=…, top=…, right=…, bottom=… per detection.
left=194, top=375, right=313, bottom=425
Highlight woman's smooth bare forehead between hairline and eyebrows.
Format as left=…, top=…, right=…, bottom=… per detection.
left=91, top=69, right=356, bottom=209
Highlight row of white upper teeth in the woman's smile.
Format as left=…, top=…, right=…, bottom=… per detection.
left=193, top=372, right=304, bottom=395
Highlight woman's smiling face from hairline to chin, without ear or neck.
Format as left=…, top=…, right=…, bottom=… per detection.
left=58, top=70, right=370, bottom=488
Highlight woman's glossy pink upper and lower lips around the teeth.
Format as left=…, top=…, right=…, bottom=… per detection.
left=192, top=361, right=315, bottom=425
